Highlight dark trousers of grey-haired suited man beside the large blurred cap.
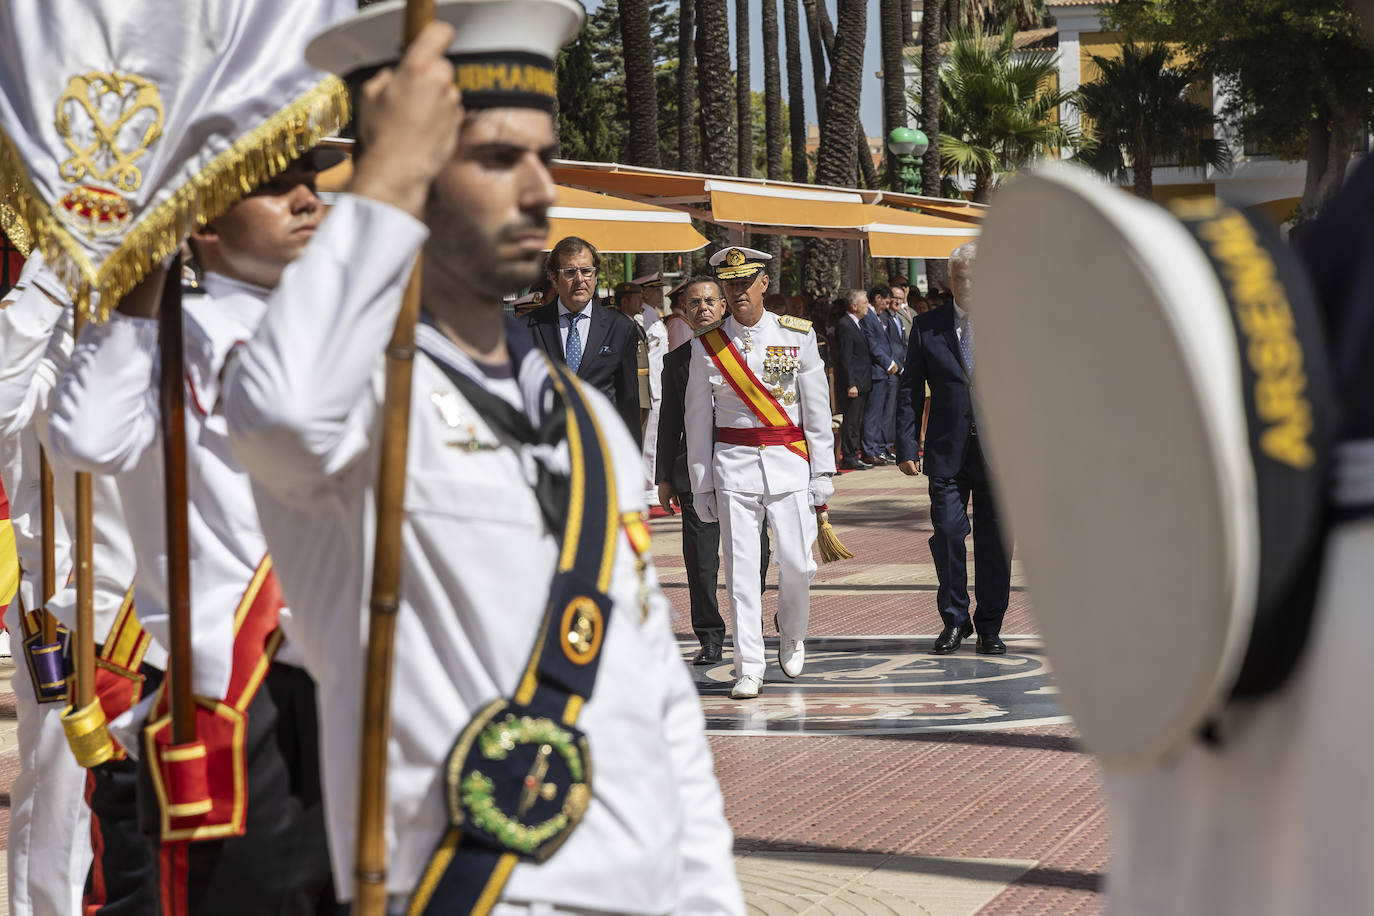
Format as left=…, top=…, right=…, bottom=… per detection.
left=930, top=435, right=1011, bottom=636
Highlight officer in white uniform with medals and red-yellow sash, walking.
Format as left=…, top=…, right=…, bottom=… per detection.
left=686, top=246, right=835, bottom=698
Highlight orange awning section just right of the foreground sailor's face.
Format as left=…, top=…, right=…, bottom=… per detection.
left=547, top=187, right=706, bottom=254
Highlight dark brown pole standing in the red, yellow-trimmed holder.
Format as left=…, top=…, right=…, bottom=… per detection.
left=158, top=255, right=195, bottom=744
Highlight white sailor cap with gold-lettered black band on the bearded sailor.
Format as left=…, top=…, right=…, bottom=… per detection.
left=305, top=0, right=587, bottom=111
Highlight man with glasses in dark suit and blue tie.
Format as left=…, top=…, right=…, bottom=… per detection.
left=529, top=236, right=643, bottom=442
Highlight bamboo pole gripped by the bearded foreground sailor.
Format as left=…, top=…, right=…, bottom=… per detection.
left=353, top=0, right=434, bottom=916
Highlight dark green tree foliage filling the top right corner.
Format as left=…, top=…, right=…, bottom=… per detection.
left=1107, top=0, right=1374, bottom=218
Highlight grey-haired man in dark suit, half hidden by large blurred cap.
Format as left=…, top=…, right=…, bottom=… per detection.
left=897, top=242, right=1011, bottom=655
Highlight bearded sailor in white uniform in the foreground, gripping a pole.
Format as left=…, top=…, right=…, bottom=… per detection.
left=224, top=8, right=743, bottom=913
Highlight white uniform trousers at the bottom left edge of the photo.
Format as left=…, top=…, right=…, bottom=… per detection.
left=4, top=602, right=91, bottom=916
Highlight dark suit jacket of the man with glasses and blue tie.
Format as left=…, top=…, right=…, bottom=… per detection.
left=528, top=299, right=643, bottom=442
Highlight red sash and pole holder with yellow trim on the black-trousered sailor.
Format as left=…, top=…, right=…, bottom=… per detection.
left=143, top=556, right=283, bottom=843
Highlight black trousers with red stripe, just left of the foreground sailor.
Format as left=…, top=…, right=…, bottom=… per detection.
left=139, top=663, right=339, bottom=916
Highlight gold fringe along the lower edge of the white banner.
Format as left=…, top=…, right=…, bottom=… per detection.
left=0, top=77, right=349, bottom=324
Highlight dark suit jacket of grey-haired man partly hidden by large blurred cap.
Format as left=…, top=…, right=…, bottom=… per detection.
left=897, top=308, right=973, bottom=477
